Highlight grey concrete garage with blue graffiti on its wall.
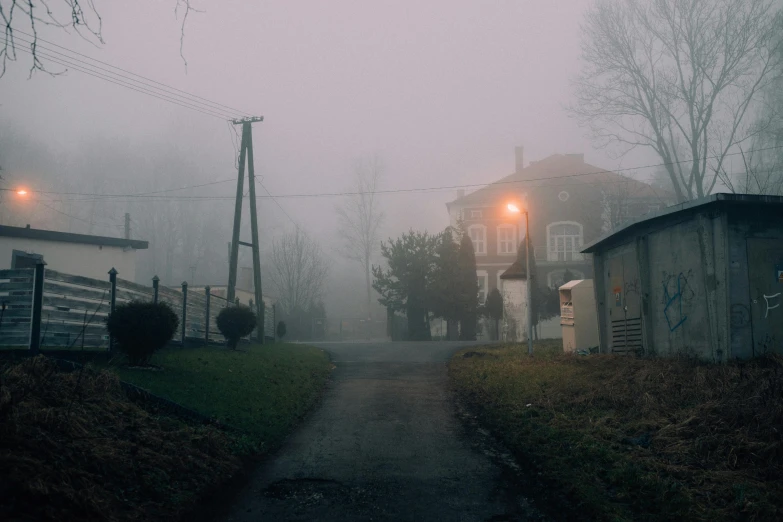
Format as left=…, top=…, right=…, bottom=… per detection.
left=582, top=194, right=783, bottom=362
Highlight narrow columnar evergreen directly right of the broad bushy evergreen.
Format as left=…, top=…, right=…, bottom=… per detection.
left=430, top=227, right=462, bottom=341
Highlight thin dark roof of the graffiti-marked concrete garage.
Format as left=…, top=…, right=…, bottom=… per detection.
left=582, top=193, right=783, bottom=254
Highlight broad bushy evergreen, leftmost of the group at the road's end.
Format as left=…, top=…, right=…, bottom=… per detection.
left=372, top=230, right=438, bottom=341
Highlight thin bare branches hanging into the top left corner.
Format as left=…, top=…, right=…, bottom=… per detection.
left=0, top=0, right=197, bottom=77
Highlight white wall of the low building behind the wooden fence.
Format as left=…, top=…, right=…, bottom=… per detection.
left=0, top=237, right=139, bottom=285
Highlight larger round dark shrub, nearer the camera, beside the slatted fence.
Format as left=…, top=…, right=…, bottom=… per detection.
left=106, top=301, right=179, bottom=366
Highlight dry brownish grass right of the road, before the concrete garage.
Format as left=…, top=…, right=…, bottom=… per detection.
left=450, top=343, right=783, bottom=520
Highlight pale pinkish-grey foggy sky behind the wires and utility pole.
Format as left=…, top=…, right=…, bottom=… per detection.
left=0, top=0, right=650, bottom=317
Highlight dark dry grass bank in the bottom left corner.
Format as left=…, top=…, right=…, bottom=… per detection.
left=0, top=356, right=241, bottom=521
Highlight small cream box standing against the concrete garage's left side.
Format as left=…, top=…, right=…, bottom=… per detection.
left=560, top=279, right=598, bottom=352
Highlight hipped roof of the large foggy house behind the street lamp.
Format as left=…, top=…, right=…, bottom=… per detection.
left=446, top=154, right=673, bottom=207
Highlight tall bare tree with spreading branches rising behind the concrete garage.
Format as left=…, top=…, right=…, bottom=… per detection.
left=569, top=0, right=781, bottom=201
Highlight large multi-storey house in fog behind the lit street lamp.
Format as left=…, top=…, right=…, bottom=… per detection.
left=446, top=147, right=673, bottom=302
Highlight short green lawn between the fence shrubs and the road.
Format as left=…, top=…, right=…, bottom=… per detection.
left=100, top=344, right=331, bottom=451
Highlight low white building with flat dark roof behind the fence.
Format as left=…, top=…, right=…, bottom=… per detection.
left=0, top=225, right=149, bottom=281
